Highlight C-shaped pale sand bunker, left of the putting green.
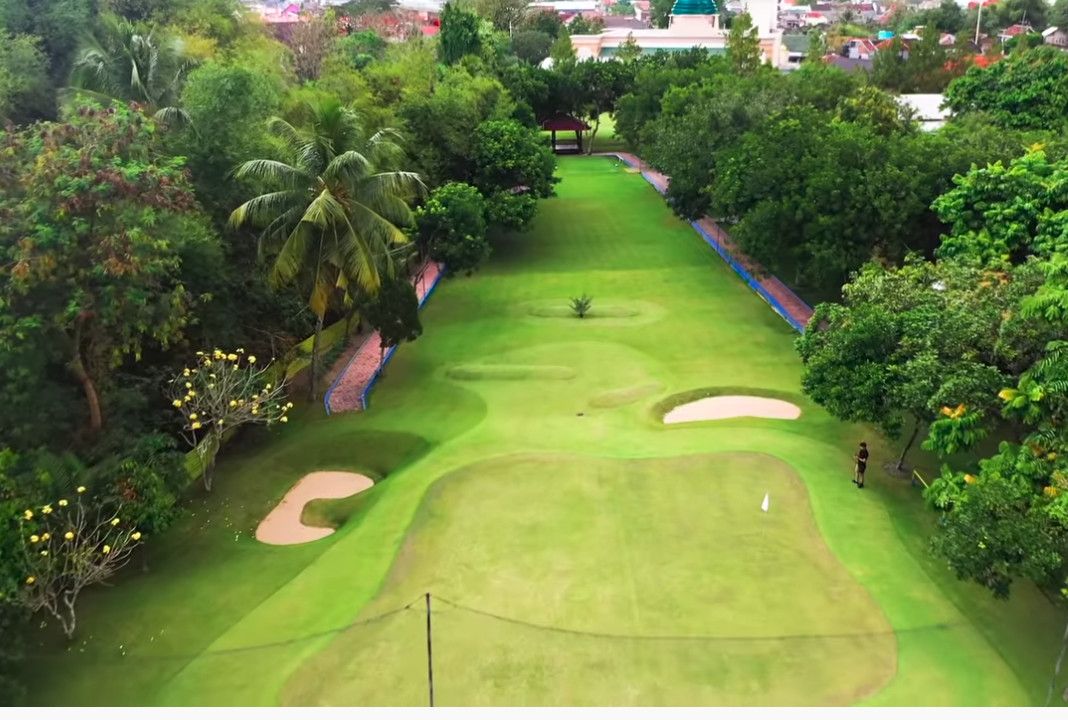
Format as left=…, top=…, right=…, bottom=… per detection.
left=256, top=472, right=375, bottom=545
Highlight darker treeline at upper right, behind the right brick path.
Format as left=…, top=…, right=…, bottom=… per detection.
left=616, top=40, right=1068, bottom=298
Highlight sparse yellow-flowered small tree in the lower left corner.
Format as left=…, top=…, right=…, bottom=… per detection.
left=17, top=486, right=143, bottom=638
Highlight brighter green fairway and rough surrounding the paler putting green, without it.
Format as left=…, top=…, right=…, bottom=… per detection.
left=30, top=158, right=1063, bottom=704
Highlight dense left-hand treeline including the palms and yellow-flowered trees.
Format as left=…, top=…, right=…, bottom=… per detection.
left=0, top=0, right=568, bottom=703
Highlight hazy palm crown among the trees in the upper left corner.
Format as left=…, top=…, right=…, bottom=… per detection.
left=70, top=15, right=190, bottom=120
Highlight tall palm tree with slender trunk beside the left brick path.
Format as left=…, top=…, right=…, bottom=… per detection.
left=230, top=98, right=424, bottom=398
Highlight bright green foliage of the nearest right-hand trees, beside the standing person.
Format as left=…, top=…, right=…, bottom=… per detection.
left=798, top=151, right=1068, bottom=597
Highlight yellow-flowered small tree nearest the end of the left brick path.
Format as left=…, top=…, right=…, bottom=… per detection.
left=170, top=348, right=293, bottom=490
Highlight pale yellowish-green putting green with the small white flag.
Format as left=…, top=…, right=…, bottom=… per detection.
left=282, top=453, right=896, bottom=705
